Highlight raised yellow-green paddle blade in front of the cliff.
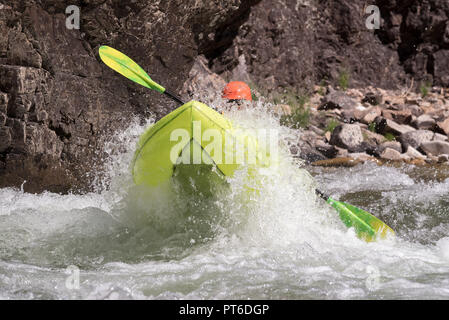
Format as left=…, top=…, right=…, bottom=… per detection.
left=98, top=46, right=165, bottom=93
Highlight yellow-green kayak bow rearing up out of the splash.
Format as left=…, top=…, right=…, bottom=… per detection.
left=132, top=101, right=268, bottom=186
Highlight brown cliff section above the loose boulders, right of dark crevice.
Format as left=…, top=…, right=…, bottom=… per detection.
left=210, top=0, right=449, bottom=90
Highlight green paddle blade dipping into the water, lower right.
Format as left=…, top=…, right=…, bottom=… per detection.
left=327, top=198, right=395, bottom=242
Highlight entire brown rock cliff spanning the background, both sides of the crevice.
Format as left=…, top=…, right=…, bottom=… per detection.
left=0, top=0, right=449, bottom=192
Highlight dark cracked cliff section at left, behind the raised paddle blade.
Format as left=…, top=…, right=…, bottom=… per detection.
left=0, top=0, right=253, bottom=192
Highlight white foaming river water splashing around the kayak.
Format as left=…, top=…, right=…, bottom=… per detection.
left=0, top=101, right=449, bottom=299
